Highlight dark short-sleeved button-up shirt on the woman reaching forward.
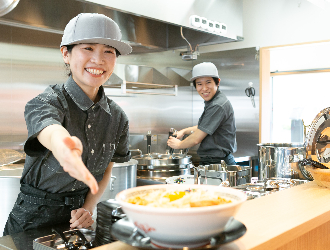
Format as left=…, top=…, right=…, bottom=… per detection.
left=21, top=77, right=130, bottom=193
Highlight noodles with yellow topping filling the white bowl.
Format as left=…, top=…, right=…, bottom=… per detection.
left=126, top=189, right=231, bottom=208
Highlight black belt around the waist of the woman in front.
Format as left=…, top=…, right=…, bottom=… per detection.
left=19, top=183, right=89, bottom=209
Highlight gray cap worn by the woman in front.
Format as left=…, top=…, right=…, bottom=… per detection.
left=60, top=13, right=132, bottom=55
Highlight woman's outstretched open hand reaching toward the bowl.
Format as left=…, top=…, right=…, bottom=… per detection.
left=60, top=136, right=99, bottom=194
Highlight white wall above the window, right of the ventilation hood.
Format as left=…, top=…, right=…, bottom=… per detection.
left=200, top=0, right=330, bottom=52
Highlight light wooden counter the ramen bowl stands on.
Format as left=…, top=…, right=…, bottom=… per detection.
left=95, top=182, right=330, bottom=250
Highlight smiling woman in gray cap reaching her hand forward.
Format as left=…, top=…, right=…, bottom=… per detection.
left=4, top=13, right=131, bottom=235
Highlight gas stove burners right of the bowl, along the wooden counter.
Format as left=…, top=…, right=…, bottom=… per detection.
left=233, top=178, right=308, bottom=200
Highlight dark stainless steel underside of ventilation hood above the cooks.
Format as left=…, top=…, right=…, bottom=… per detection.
left=0, top=0, right=243, bottom=54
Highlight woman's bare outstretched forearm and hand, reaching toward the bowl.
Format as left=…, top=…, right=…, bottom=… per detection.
left=38, top=124, right=98, bottom=194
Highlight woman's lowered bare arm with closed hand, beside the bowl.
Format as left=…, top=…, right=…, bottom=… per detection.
left=70, top=162, right=114, bottom=228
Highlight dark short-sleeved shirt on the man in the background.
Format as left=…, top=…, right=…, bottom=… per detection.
left=197, top=89, right=236, bottom=157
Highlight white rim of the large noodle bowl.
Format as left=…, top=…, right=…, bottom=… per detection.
left=115, top=184, right=247, bottom=214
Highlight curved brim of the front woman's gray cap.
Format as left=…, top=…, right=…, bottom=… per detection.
left=61, top=38, right=132, bottom=55
